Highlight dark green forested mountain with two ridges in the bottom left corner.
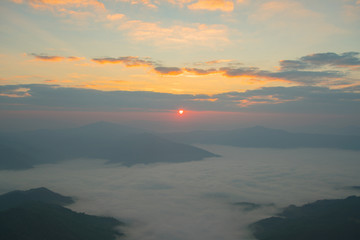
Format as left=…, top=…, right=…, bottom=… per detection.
left=0, top=188, right=123, bottom=240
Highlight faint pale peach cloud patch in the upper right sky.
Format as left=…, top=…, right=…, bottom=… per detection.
left=248, top=0, right=345, bottom=43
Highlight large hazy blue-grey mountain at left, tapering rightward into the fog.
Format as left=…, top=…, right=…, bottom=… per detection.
left=0, top=122, right=217, bottom=169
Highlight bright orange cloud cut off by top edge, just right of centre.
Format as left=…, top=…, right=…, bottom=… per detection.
left=188, top=0, right=234, bottom=12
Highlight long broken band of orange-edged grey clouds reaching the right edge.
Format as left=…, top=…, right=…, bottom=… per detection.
left=92, top=52, right=360, bottom=86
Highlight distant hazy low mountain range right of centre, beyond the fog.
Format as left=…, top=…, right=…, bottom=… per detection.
left=163, top=126, right=360, bottom=150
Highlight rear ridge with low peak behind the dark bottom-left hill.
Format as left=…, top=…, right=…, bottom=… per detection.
left=0, top=187, right=74, bottom=211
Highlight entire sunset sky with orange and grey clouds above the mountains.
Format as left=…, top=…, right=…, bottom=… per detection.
left=0, top=0, right=360, bottom=130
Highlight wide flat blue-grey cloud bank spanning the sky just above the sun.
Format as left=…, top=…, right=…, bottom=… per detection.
left=0, top=84, right=360, bottom=114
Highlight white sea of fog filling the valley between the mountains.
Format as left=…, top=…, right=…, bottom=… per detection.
left=0, top=145, right=360, bottom=240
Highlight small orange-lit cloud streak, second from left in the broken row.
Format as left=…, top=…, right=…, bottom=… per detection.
left=92, top=56, right=156, bottom=67
